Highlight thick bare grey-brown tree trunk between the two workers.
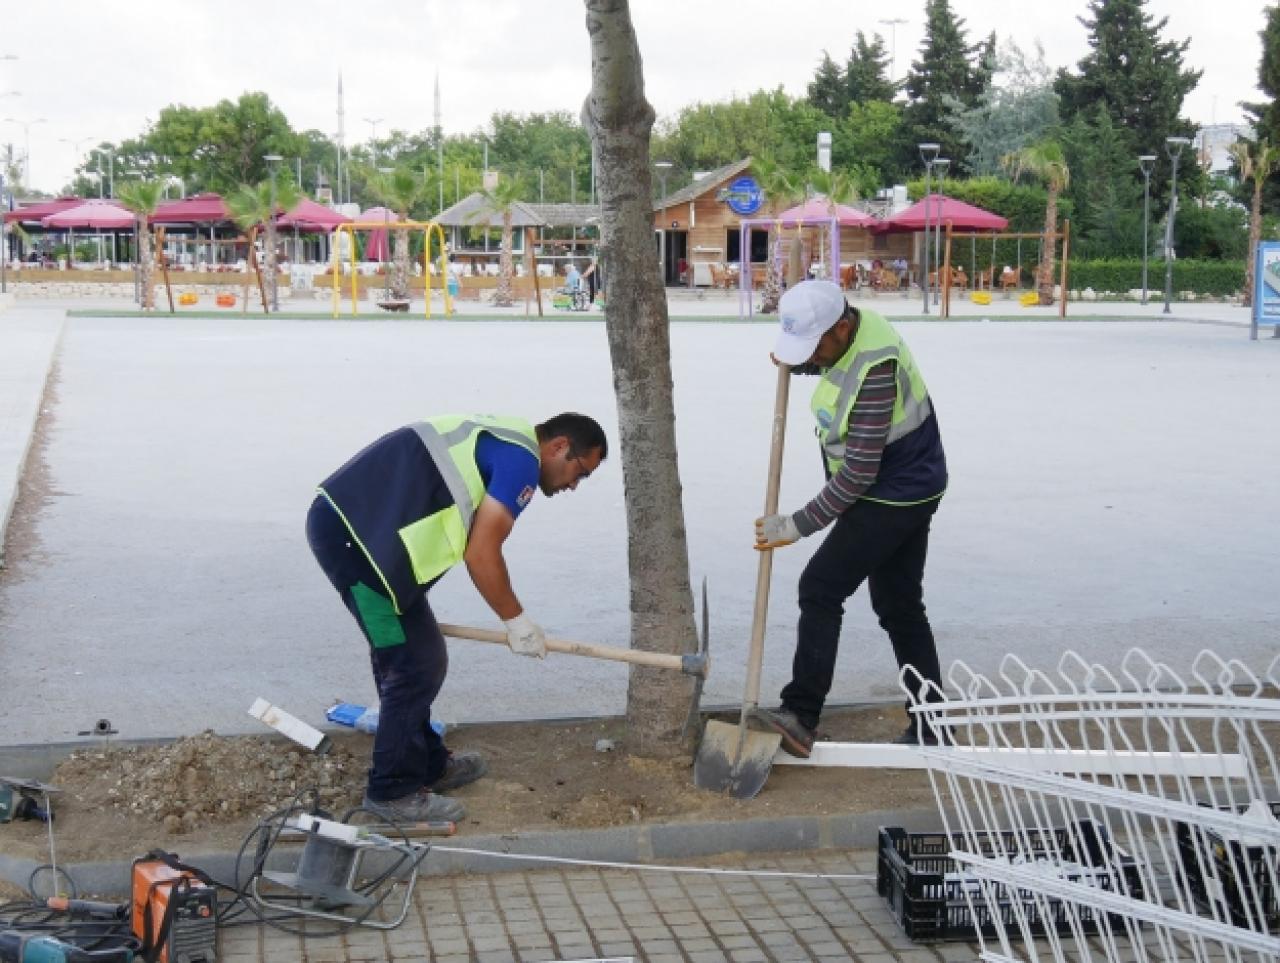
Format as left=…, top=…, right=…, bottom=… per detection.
left=582, top=0, right=696, bottom=757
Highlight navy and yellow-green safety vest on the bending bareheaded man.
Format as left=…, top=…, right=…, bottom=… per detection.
left=319, top=415, right=539, bottom=613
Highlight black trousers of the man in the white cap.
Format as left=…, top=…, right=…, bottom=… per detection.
left=782, top=499, right=941, bottom=729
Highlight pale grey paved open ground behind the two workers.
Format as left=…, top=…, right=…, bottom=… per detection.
left=0, top=295, right=1280, bottom=744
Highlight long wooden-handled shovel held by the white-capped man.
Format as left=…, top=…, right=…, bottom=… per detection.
left=694, top=365, right=791, bottom=799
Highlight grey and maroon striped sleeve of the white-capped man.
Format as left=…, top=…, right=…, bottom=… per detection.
left=791, top=361, right=897, bottom=535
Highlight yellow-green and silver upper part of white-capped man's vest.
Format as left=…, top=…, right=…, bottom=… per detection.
left=810, top=310, right=933, bottom=474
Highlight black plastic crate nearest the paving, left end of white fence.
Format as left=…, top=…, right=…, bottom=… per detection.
left=876, top=821, right=1142, bottom=943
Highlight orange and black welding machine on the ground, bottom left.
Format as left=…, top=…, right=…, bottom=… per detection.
left=132, top=850, right=218, bottom=963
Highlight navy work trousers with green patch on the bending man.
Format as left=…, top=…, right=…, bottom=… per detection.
left=307, top=496, right=449, bottom=803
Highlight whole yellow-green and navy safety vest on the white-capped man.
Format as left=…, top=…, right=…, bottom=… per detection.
left=809, top=309, right=947, bottom=505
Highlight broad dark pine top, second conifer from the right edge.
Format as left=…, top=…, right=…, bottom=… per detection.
left=1053, top=0, right=1202, bottom=152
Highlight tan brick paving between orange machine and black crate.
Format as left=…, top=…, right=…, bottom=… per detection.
left=218, top=850, right=977, bottom=963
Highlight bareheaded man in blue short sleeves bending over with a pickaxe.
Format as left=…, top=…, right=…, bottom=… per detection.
left=307, top=412, right=608, bottom=822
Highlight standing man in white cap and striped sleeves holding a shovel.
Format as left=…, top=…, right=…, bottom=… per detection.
left=755, top=280, right=947, bottom=757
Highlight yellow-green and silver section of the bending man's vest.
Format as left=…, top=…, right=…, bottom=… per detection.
left=399, top=415, right=539, bottom=585
